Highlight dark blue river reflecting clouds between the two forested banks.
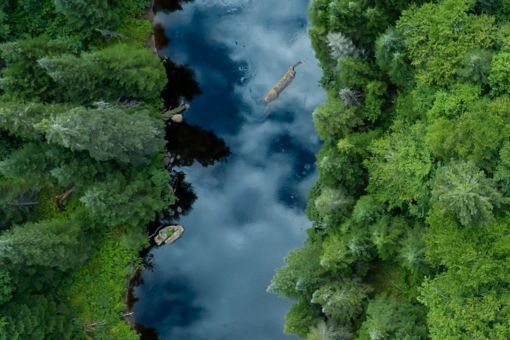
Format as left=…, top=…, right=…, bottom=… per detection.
left=134, top=0, right=324, bottom=340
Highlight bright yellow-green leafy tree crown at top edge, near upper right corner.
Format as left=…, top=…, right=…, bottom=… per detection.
left=397, top=0, right=495, bottom=86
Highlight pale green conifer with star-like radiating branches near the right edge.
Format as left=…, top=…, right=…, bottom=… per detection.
left=432, top=162, right=502, bottom=227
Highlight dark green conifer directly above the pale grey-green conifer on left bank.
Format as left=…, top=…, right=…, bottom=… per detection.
left=38, top=44, right=166, bottom=104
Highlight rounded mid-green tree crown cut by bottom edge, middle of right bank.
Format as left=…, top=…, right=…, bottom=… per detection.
left=358, top=295, right=427, bottom=340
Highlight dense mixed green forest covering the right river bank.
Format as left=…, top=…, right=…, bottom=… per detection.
left=268, top=0, right=510, bottom=340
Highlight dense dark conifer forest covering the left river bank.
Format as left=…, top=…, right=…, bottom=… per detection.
left=0, top=0, right=175, bottom=340
